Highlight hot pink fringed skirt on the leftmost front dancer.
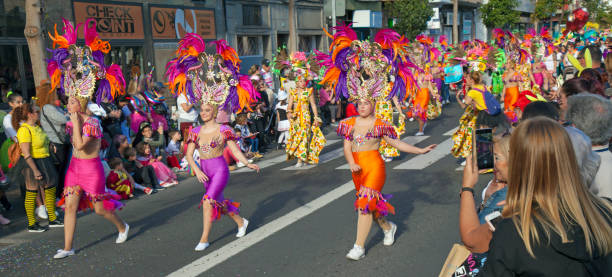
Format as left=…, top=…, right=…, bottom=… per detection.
left=57, top=157, right=123, bottom=211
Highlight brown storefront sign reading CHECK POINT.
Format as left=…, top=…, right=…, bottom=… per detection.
left=72, top=1, right=144, bottom=40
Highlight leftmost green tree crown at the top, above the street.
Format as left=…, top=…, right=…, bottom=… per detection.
left=385, top=0, right=434, bottom=39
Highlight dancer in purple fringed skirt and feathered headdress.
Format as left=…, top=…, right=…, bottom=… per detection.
left=166, top=33, right=259, bottom=251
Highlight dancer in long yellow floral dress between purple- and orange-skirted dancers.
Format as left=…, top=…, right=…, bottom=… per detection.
left=285, top=52, right=326, bottom=167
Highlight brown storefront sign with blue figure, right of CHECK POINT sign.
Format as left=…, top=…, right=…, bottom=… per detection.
left=149, top=5, right=217, bottom=39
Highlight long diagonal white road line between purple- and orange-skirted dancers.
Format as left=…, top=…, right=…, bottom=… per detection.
left=168, top=181, right=355, bottom=277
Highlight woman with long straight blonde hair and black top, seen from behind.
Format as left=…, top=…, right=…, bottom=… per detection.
left=482, top=117, right=612, bottom=276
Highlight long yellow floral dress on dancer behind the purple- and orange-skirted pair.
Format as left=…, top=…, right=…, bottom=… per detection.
left=286, top=88, right=326, bottom=164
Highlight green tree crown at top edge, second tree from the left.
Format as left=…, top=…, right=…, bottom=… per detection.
left=480, top=0, right=521, bottom=28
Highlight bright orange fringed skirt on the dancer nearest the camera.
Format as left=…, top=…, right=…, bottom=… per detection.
left=353, top=150, right=395, bottom=218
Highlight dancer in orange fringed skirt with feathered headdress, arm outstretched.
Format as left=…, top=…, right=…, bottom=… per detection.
left=323, top=26, right=435, bottom=260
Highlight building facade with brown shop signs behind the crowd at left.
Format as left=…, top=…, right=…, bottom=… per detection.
left=0, top=0, right=328, bottom=97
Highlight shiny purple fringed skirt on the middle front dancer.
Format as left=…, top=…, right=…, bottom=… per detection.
left=200, top=156, right=240, bottom=221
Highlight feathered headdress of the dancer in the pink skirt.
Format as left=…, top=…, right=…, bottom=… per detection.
left=47, top=18, right=125, bottom=103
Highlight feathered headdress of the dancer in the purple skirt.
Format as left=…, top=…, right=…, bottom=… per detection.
left=166, top=33, right=259, bottom=112
